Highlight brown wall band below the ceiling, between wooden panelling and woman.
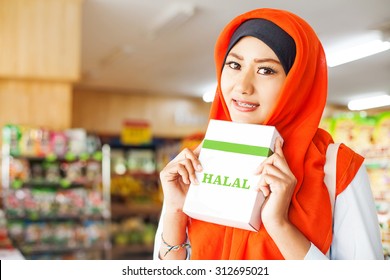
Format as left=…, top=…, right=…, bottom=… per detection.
left=72, top=90, right=211, bottom=137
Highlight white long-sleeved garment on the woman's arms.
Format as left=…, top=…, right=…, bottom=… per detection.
left=153, top=165, right=384, bottom=260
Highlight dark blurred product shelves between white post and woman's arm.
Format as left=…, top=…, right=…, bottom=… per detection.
left=101, top=135, right=184, bottom=259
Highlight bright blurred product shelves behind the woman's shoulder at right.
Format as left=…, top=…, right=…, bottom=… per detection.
left=323, top=112, right=390, bottom=259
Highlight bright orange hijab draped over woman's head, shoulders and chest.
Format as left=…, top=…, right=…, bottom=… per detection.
left=188, top=9, right=363, bottom=259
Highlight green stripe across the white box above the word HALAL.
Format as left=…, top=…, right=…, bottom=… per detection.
left=202, top=139, right=272, bottom=157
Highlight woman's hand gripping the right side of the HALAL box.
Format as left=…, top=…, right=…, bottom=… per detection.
left=256, top=138, right=297, bottom=231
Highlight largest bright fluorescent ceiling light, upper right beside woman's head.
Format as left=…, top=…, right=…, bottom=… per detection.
left=326, top=40, right=390, bottom=67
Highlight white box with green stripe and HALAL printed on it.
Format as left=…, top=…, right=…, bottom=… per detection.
left=183, top=120, right=280, bottom=231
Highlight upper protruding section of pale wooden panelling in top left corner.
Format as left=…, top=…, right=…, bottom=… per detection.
left=0, top=0, right=82, bottom=81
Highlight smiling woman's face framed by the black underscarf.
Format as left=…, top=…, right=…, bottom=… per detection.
left=221, top=37, right=286, bottom=124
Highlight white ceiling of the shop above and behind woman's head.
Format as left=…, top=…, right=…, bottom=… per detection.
left=77, top=0, right=390, bottom=105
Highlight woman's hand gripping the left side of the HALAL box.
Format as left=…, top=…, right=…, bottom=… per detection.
left=160, top=144, right=202, bottom=212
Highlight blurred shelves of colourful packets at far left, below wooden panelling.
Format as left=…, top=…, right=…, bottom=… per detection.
left=2, top=125, right=110, bottom=259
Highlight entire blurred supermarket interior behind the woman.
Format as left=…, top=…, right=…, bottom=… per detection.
left=0, top=0, right=390, bottom=259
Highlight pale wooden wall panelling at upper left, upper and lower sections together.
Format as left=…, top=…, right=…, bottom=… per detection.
left=0, top=0, right=82, bottom=133
